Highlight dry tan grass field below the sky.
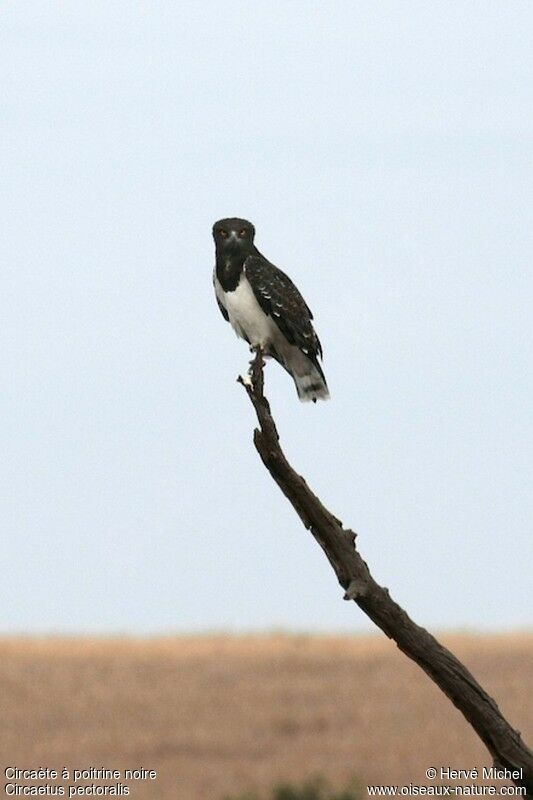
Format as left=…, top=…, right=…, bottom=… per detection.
left=0, top=634, right=533, bottom=800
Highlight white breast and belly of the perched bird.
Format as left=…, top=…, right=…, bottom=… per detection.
left=215, top=272, right=279, bottom=349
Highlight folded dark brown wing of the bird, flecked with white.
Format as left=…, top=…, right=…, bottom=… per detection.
left=244, top=253, right=322, bottom=362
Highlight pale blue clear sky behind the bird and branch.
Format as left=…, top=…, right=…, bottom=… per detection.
left=0, top=0, right=533, bottom=633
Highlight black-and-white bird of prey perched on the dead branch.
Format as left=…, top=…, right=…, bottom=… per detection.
left=213, top=218, right=329, bottom=403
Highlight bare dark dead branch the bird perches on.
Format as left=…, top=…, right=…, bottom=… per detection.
left=239, top=352, right=533, bottom=797
